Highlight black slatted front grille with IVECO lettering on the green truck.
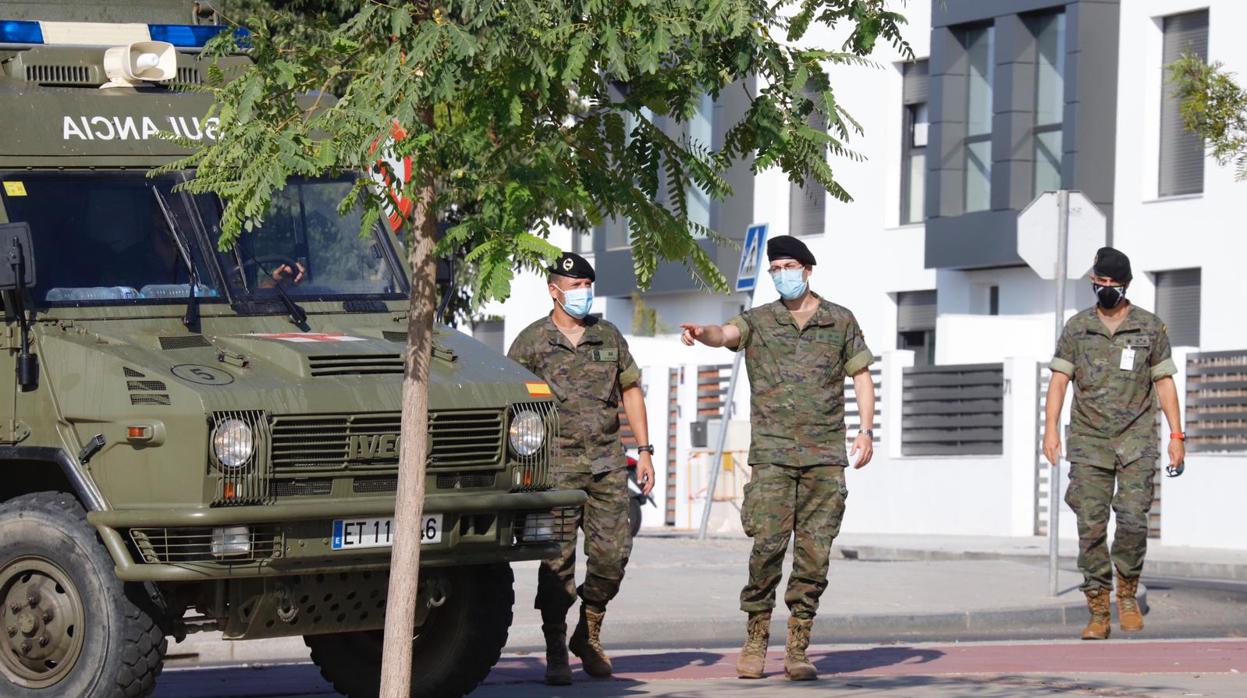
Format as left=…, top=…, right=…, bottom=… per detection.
left=272, top=410, right=505, bottom=475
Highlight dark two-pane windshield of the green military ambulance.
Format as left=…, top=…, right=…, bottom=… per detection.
left=0, top=171, right=405, bottom=306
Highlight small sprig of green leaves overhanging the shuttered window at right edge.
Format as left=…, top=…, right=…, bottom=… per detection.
left=1168, top=55, right=1247, bottom=179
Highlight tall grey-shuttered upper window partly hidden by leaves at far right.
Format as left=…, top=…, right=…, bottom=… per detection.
left=1160, top=10, right=1208, bottom=196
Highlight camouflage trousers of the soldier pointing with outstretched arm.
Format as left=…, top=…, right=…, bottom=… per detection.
left=741, top=464, right=849, bottom=618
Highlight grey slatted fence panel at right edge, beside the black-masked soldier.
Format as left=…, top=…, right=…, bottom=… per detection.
left=1186, top=350, right=1247, bottom=452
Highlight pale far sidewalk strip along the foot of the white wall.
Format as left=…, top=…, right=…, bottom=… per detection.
left=835, top=533, right=1247, bottom=581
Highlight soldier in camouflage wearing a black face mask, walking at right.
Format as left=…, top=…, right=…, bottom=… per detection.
left=1044, top=247, right=1185, bottom=639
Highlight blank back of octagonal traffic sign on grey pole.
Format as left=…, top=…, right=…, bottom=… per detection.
left=1018, top=192, right=1107, bottom=279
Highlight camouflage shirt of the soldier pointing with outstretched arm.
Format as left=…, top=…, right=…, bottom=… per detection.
left=728, top=295, right=874, bottom=466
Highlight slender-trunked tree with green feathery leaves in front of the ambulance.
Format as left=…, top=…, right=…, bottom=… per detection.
left=172, top=0, right=910, bottom=697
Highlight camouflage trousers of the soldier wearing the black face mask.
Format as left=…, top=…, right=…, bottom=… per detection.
left=1065, top=456, right=1156, bottom=591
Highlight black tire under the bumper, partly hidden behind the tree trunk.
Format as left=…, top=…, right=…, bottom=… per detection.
left=303, top=563, right=515, bottom=698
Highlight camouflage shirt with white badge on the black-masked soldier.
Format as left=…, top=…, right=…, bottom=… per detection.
left=1049, top=305, right=1177, bottom=469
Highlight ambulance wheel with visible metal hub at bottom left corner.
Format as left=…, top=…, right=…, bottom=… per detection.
left=0, top=492, right=166, bottom=698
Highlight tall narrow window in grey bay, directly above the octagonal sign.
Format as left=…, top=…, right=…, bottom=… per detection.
left=1026, top=11, right=1065, bottom=194
